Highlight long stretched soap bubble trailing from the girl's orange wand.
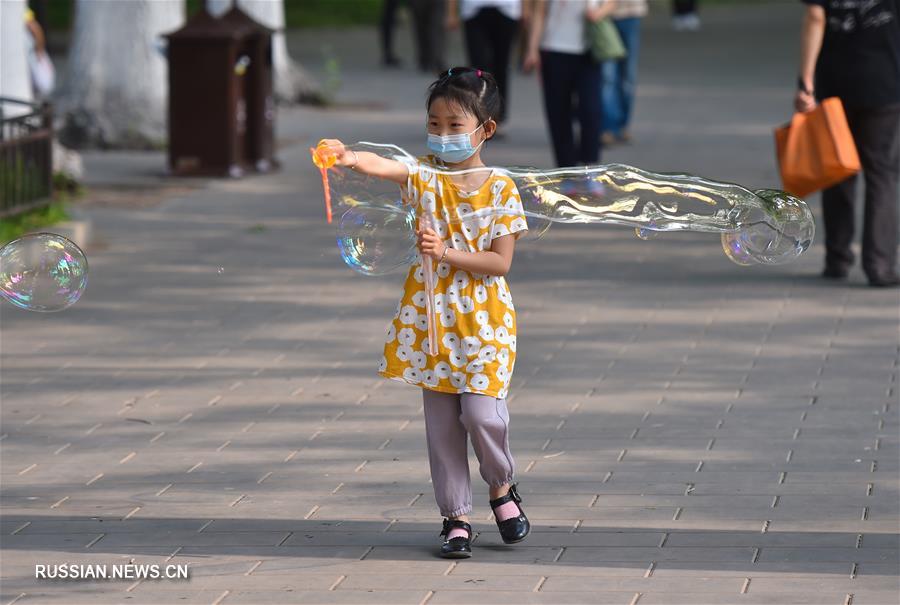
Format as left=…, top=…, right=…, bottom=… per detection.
left=314, top=142, right=815, bottom=274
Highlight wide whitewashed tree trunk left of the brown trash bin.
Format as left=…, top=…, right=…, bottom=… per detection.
left=57, top=0, right=184, bottom=149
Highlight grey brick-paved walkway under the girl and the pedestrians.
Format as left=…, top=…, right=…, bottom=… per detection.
left=0, top=4, right=900, bottom=605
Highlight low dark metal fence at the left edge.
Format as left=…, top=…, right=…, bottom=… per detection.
left=0, top=97, right=53, bottom=218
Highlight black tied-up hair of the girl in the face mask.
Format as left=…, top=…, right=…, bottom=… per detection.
left=425, top=67, right=500, bottom=124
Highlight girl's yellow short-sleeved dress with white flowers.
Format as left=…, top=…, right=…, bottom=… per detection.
left=378, top=156, right=528, bottom=399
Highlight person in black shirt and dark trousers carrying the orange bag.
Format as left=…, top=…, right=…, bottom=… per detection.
left=794, top=0, right=900, bottom=287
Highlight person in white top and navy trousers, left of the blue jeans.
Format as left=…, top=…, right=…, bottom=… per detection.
left=522, top=0, right=616, bottom=166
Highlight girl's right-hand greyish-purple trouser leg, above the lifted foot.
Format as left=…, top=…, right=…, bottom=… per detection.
left=459, top=393, right=515, bottom=487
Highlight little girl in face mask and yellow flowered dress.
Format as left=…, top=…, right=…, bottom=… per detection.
left=316, top=67, right=530, bottom=558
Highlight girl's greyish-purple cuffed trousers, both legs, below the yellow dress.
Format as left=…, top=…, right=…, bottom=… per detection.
left=422, top=389, right=515, bottom=517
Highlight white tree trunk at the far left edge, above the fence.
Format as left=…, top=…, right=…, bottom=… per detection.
left=0, top=0, right=34, bottom=118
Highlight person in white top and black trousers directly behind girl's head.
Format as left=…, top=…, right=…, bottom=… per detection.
left=447, top=0, right=527, bottom=129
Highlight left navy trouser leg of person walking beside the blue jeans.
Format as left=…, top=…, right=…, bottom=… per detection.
left=541, top=50, right=581, bottom=166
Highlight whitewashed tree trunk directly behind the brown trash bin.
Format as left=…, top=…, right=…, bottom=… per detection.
left=207, top=0, right=322, bottom=103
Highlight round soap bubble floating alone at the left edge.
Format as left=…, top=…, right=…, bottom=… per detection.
left=0, top=233, right=88, bottom=312
